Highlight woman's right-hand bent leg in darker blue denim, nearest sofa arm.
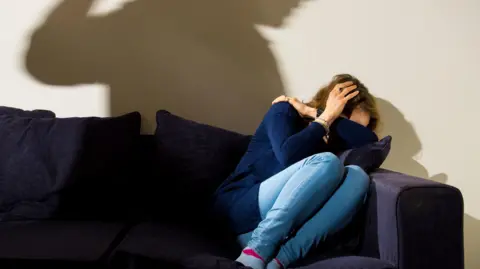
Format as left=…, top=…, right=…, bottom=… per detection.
left=269, top=166, right=370, bottom=268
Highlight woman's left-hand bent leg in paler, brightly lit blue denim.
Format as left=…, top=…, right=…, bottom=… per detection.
left=237, top=153, right=344, bottom=265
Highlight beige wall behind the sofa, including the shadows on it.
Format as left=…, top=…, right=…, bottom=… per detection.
left=0, top=0, right=480, bottom=269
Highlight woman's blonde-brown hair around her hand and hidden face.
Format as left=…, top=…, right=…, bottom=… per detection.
left=307, top=74, right=380, bottom=131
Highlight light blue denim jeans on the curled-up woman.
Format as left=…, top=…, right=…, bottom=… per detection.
left=238, top=153, right=370, bottom=268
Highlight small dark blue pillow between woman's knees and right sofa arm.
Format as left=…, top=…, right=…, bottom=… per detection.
left=337, top=136, right=392, bottom=173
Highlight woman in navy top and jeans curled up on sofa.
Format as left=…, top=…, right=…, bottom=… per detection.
left=214, top=75, right=379, bottom=269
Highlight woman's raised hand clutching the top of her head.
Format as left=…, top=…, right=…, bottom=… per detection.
left=320, top=81, right=358, bottom=125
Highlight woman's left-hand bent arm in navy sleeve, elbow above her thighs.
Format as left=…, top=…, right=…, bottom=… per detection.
left=264, top=102, right=327, bottom=166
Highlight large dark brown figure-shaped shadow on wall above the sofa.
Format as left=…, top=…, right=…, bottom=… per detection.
left=26, top=0, right=301, bottom=133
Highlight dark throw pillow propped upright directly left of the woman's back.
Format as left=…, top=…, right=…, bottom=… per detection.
left=155, top=110, right=250, bottom=217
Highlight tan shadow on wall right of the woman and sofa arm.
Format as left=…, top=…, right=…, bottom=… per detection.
left=377, top=98, right=480, bottom=269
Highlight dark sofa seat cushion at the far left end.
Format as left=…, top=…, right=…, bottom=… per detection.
left=0, top=221, right=126, bottom=261
